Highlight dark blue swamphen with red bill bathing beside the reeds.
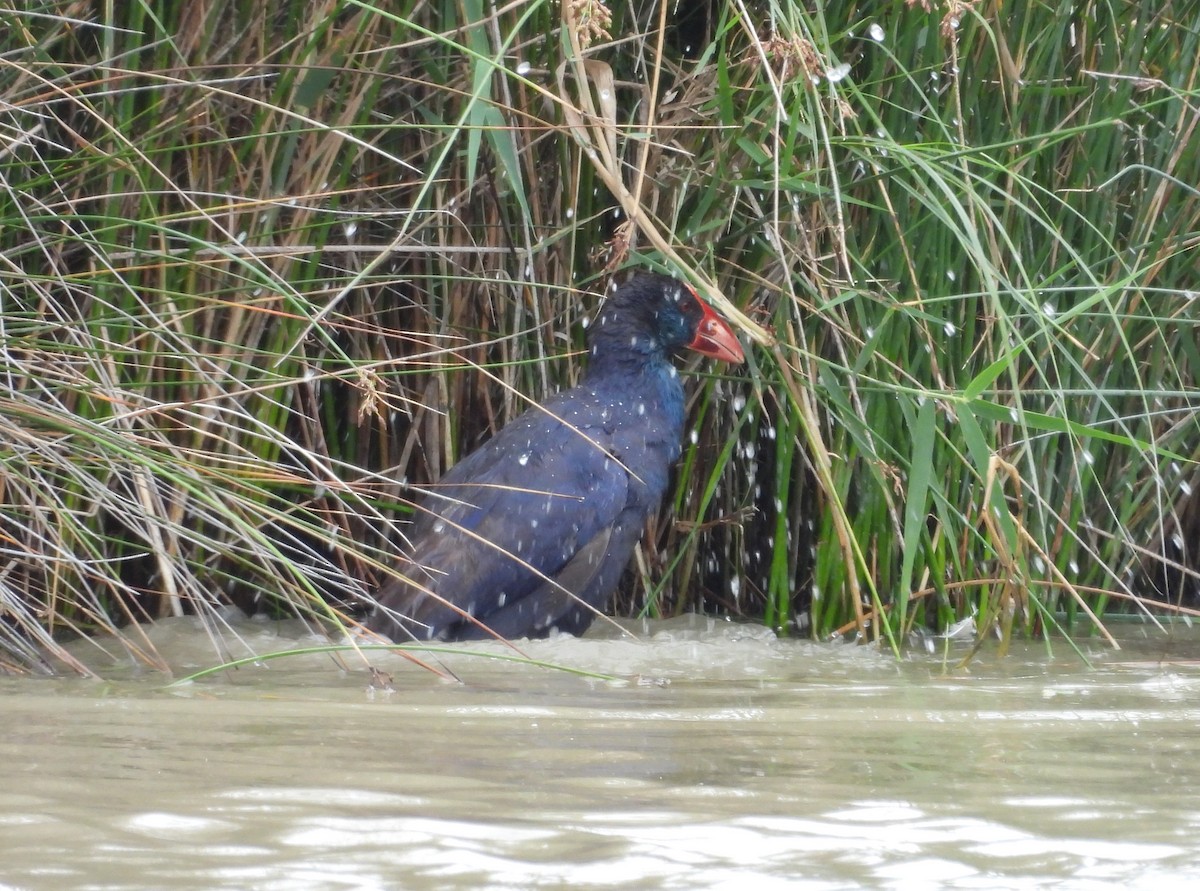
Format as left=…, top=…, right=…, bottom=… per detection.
left=370, top=274, right=745, bottom=641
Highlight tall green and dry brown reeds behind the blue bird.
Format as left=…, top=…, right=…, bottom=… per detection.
left=0, top=0, right=1200, bottom=671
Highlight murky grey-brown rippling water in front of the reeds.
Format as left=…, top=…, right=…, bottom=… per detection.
left=0, top=622, right=1200, bottom=891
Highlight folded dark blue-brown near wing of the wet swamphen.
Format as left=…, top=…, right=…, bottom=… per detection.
left=378, top=400, right=629, bottom=638
